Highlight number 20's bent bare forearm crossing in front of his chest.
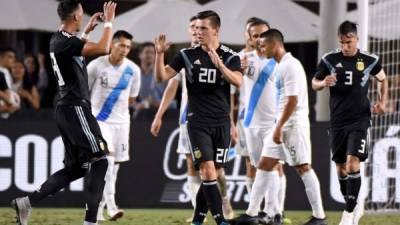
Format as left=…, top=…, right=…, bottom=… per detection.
left=208, top=49, right=243, bottom=87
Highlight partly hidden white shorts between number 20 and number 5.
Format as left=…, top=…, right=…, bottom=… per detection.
left=244, top=128, right=272, bottom=166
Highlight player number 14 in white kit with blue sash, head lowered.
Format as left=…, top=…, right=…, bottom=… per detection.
left=88, top=30, right=140, bottom=221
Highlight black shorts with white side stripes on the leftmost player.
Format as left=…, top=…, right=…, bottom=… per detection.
left=55, top=105, right=108, bottom=167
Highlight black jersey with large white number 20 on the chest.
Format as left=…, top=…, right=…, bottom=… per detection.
left=170, top=45, right=241, bottom=126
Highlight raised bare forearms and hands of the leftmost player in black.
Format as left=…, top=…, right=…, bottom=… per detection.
left=82, top=1, right=117, bottom=57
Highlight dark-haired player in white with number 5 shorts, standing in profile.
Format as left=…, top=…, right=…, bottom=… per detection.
left=233, top=29, right=326, bottom=225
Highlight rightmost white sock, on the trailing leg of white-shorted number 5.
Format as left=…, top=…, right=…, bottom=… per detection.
left=301, top=169, right=325, bottom=219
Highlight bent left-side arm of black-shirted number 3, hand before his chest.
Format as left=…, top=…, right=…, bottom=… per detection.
left=311, top=60, right=337, bottom=91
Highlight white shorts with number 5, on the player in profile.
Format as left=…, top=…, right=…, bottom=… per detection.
left=262, top=125, right=311, bottom=166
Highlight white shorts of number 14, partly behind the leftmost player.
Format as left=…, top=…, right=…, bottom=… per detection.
left=98, top=121, right=130, bottom=162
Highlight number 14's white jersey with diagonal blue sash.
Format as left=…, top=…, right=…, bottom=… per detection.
left=87, top=56, right=140, bottom=123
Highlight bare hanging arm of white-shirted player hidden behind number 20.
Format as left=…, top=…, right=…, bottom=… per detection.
left=150, top=79, right=179, bottom=136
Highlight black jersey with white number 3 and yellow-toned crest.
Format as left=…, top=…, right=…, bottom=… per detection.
left=315, top=50, right=382, bottom=127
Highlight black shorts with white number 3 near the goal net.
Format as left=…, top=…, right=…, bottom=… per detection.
left=328, top=120, right=370, bottom=163
